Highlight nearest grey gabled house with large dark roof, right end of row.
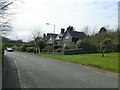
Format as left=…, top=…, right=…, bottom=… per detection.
left=61, top=26, right=86, bottom=48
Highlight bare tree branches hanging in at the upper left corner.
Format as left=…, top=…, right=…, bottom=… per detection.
left=0, top=0, right=23, bottom=37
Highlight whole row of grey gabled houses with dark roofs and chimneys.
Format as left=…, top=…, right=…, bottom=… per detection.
left=43, top=26, right=86, bottom=48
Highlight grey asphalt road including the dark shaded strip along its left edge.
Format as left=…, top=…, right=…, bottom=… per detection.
left=3, top=52, right=118, bottom=88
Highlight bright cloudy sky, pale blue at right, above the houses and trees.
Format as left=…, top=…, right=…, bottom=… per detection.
left=8, top=0, right=118, bottom=41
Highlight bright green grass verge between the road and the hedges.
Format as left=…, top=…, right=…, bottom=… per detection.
left=20, top=52, right=120, bottom=73
